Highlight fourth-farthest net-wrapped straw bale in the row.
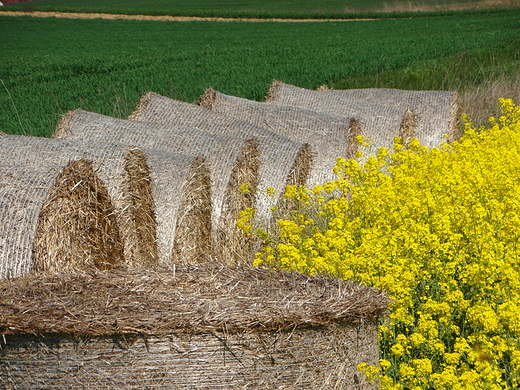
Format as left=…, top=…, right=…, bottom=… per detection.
left=129, top=92, right=314, bottom=223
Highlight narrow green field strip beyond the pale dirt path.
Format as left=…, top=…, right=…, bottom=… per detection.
left=5, top=0, right=520, bottom=18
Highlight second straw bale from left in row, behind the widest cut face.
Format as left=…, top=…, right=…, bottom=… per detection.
left=0, top=135, right=158, bottom=266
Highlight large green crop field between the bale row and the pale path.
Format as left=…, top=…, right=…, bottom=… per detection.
left=0, top=10, right=520, bottom=136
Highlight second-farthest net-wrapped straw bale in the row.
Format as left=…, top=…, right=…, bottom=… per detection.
left=266, top=81, right=426, bottom=156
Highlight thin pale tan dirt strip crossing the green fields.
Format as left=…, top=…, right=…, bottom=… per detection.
left=0, top=11, right=374, bottom=22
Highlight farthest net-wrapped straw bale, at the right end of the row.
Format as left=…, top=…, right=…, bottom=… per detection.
left=319, top=87, right=461, bottom=143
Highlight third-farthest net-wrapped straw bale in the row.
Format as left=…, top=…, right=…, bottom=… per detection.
left=199, top=88, right=354, bottom=186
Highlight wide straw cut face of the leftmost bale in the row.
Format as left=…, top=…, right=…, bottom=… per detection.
left=33, top=160, right=123, bottom=273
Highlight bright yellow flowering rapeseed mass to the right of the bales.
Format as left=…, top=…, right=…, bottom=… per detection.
left=241, top=99, right=520, bottom=390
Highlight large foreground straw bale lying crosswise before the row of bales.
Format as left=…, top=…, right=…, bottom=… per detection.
left=0, top=263, right=388, bottom=389
